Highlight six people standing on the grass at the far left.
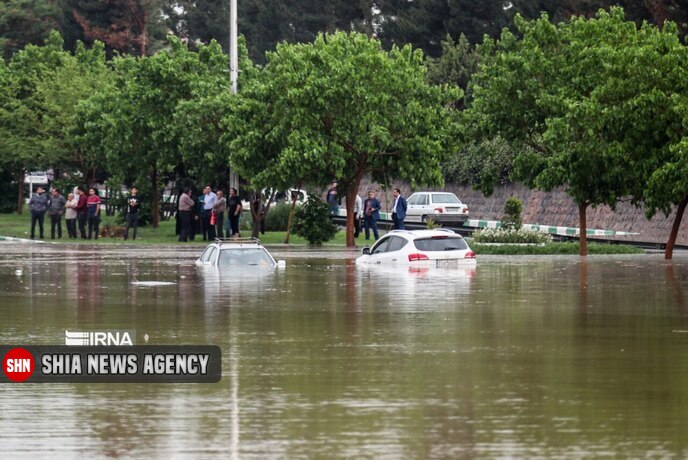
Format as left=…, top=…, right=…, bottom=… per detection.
left=29, top=187, right=140, bottom=240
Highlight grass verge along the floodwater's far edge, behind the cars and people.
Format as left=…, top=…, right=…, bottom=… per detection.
left=0, top=212, right=643, bottom=255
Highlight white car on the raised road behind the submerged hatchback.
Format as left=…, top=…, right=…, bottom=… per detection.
left=404, top=192, right=468, bottom=223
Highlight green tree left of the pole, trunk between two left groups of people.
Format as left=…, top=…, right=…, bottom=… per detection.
left=80, top=37, right=227, bottom=227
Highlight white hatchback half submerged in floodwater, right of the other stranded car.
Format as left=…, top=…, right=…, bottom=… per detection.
left=356, top=228, right=476, bottom=267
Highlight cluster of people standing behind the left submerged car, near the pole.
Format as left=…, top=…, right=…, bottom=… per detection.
left=178, top=185, right=243, bottom=242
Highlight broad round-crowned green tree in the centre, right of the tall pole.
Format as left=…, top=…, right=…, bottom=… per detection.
left=230, top=32, right=461, bottom=246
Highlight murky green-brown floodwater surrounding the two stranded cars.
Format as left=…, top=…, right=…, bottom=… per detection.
left=0, top=243, right=688, bottom=459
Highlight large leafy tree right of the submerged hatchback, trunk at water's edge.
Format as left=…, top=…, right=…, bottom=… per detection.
left=470, top=9, right=668, bottom=255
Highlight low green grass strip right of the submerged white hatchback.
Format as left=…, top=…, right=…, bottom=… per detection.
left=469, top=242, right=644, bottom=255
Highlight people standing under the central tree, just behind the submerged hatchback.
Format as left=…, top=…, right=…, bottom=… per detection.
left=326, top=181, right=408, bottom=240
